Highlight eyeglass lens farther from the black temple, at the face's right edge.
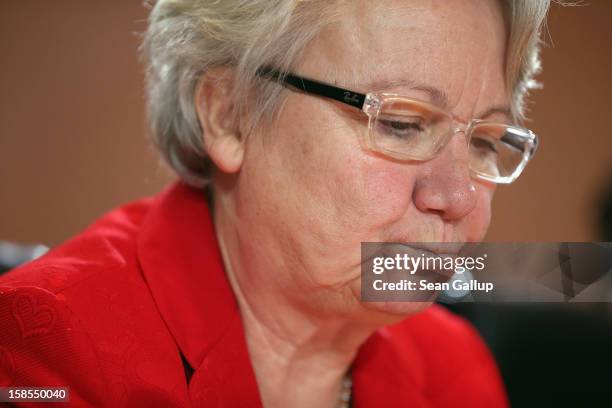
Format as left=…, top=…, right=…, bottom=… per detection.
left=469, top=124, right=531, bottom=179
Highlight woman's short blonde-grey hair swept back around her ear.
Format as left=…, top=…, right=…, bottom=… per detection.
left=142, top=0, right=550, bottom=187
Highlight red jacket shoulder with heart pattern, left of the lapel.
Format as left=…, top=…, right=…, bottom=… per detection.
left=0, top=199, right=186, bottom=406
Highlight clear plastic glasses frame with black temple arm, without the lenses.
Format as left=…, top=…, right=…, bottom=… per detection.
left=257, top=67, right=539, bottom=184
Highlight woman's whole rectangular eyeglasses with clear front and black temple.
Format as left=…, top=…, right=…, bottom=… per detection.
left=258, top=67, right=538, bottom=184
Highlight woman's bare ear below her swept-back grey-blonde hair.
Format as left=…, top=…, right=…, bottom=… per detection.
left=194, top=68, right=244, bottom=173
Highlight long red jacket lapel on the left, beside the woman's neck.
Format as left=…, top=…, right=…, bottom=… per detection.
left=137, top=182, right=259, bottom=406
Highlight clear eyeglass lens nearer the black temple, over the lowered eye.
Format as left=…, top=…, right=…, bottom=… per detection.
left=372, top=98, right=452, bottom=160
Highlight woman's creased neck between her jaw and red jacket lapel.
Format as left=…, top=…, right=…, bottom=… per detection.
left=214, top=196, right=377, bottom=407
